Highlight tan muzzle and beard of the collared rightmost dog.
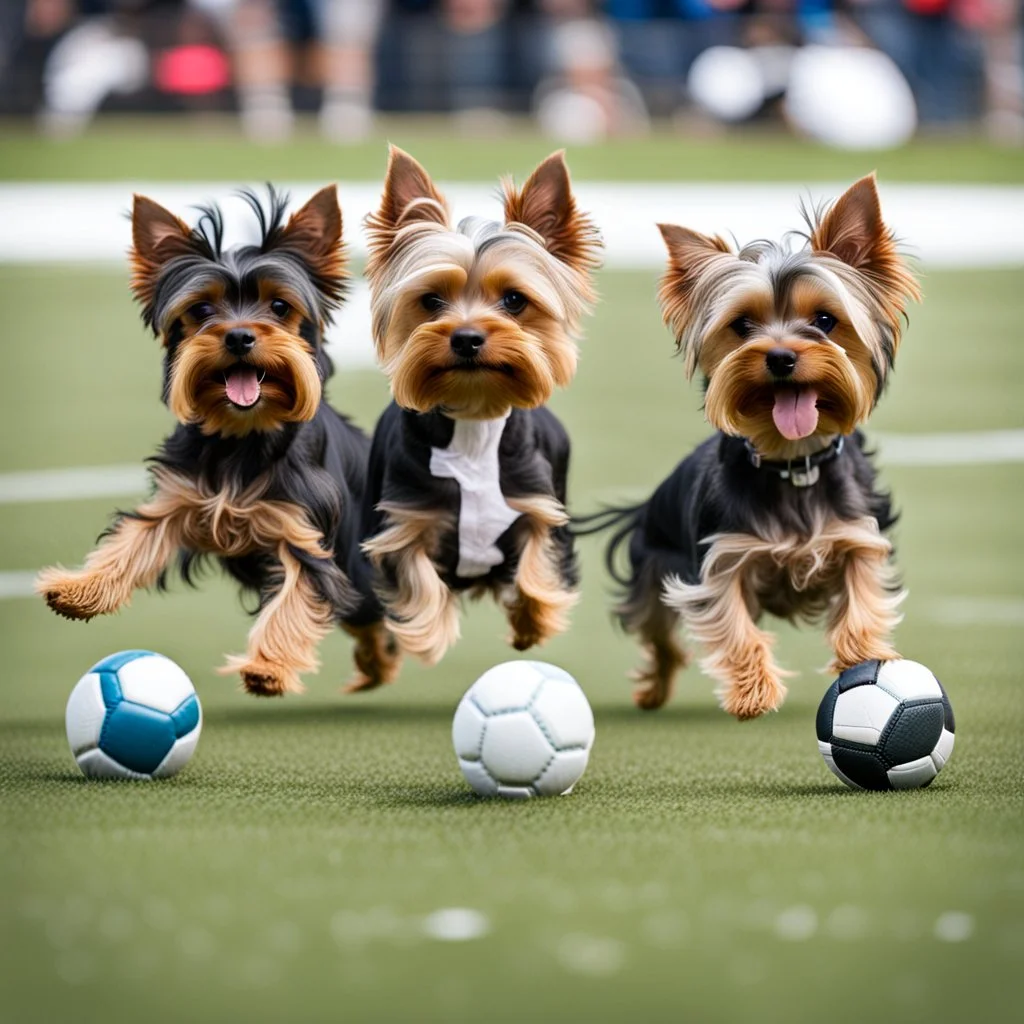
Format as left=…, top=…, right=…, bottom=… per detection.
left=705, top=341, right=878, bottom=458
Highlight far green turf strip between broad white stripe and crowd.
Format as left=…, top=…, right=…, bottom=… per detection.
left=0, top=117, right=1024, bottom=183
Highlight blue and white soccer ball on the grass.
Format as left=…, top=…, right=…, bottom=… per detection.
left=65, top=650, right=203, bottom=778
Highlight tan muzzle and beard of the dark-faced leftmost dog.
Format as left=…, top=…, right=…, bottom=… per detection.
left=168, top=329, right=323, bottom=437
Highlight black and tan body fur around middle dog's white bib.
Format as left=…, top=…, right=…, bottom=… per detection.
left=364, top=402, right=579, bottom=662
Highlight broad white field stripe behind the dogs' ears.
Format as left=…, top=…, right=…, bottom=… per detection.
left=0, top=179, right=1024, bottom=269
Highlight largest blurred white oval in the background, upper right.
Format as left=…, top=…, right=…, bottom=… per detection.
left=785, top=46, right=918, bottom=150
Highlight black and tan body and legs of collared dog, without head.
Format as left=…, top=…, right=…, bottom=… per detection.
left=574, top=431, right=902, bottom=717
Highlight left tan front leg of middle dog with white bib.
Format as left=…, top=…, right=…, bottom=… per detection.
left=362, top=504, right=460, bottom=665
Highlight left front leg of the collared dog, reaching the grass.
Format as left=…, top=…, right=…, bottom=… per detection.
left=664, top=553, right=785, bottom=719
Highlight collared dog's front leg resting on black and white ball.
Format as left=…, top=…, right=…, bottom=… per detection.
left=827, top=526, right=906, bottom=672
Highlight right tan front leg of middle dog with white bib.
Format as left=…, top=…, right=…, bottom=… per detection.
left=505, top=495, right=580, bottom=650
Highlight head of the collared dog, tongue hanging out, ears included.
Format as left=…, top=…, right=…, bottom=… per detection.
left=659, top=176, right=920, bottom=459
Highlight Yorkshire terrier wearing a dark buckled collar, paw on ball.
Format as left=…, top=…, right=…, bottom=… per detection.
left=579, top=175, right=920, bottom=719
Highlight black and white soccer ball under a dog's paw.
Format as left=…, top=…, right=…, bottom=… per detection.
left=817, top=659, right=955, bottom=790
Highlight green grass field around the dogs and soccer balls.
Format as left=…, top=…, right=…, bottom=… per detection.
left=0, top=134, right=1024, bottom=1024
